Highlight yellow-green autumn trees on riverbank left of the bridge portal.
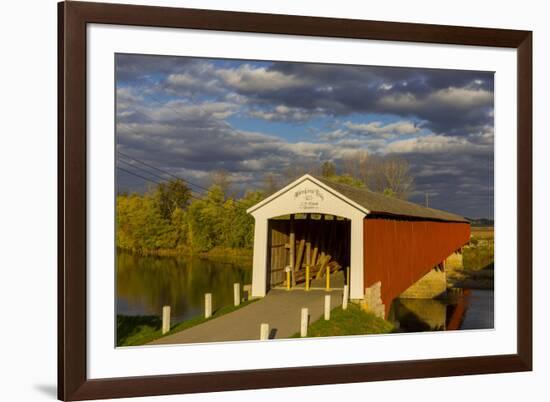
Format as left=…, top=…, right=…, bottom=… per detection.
left=116, top=179, right=262, bottom=253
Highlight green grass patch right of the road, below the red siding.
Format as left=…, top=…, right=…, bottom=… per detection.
left=291, top=303, right=395, bottom=338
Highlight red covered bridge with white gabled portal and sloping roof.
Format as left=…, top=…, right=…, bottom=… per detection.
left=247, top=174, right=470, bottom=313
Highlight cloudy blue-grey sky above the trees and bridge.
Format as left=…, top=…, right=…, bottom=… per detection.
left=115, top=54, right=494, bottom=218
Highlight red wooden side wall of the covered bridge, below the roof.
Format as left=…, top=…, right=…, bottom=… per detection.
left=364, top=218, right=470, bottom=314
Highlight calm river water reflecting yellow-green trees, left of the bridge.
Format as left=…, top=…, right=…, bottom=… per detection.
left=116, top=252, right=251, bottom=323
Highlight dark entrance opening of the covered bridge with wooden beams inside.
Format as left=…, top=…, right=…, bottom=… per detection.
left=266, top=214, right=351, bottom=289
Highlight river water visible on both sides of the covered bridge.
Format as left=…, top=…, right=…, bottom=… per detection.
left=116, top=252, right=494, bottom=332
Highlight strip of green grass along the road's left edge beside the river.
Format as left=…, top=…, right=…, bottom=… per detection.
left=117, top=299, right=257, bottom=346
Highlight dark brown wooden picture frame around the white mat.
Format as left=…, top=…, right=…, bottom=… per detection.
left=58, top=1, right=532, bottom=400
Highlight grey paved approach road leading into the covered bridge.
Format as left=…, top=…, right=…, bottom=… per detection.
left=149, top=289, right=343, bottom=345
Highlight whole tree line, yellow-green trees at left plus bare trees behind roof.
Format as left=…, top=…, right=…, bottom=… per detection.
left=116, top=152, right=413, bottom=254
